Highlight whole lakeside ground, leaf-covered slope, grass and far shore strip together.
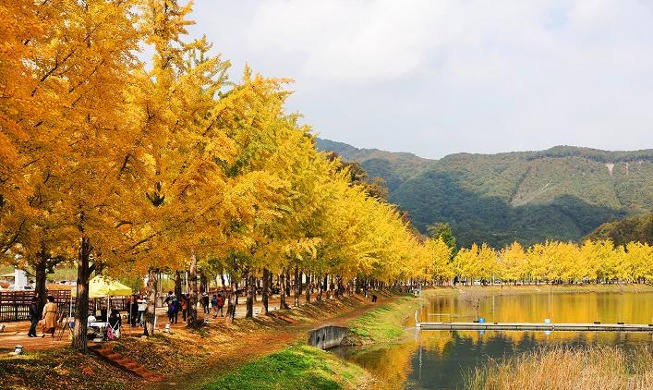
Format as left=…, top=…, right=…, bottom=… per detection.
left=0, top=285, right=653, bottom=390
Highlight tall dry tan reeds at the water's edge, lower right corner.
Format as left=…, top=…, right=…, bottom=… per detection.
left=465, top=346, right=653, bottom=390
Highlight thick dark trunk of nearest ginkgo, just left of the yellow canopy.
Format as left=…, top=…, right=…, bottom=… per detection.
left=72, top=236, right=95, bottom=353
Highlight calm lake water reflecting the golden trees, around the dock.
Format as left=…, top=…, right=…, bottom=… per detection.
left=336, top=287, right=653, bottom=389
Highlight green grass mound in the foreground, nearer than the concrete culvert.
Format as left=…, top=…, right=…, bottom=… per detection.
left=199, top=345, right=369, bottom=390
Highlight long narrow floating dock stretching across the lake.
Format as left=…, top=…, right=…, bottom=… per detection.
left=416, top=322, right=653, bottom=332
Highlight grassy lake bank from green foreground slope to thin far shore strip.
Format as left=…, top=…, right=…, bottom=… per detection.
left=183, top=285, right=653, bottom=389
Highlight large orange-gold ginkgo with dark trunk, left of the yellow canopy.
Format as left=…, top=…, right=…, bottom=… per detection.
left=0, top=0, right=148, bottom=350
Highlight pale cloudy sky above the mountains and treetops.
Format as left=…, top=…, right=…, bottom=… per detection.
left=189, top=0, right=653, bottom=158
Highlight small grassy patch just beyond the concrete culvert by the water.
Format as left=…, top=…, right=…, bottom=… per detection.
left=349, top=296, right=420, bottom=343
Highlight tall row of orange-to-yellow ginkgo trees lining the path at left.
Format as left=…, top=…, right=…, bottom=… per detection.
left=0, top=0, right=450, bottom=350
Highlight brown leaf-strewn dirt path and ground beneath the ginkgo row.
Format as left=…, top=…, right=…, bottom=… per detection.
left=0, top=295, right=392, bottom=390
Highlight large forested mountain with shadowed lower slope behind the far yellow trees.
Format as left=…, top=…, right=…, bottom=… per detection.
left=320, top=143, right=653, bottom=247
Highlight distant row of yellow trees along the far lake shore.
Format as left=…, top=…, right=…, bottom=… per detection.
left=450, top=240, right=653, bottom=283
